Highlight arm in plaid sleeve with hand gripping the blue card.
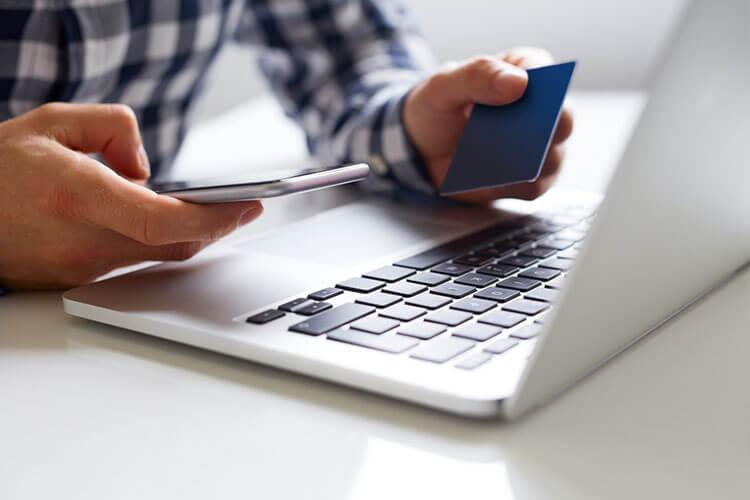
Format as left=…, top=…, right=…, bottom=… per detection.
left=239, top=0, right=572, bottom=202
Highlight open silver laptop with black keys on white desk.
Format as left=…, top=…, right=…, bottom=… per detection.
left=63, top=0, right=750, bottom=419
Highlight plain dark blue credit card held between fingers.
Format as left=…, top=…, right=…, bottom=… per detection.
left=440, top=62, right=576, bottom=194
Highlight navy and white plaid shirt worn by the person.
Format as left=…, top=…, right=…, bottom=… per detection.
left=0, top=0, right=433, bottom=195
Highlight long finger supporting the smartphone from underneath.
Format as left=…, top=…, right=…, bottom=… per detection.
left=58, top=153, right=262, bottom=246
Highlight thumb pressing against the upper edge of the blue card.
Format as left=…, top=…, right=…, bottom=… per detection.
left=425, top=57, right=528, bottom=109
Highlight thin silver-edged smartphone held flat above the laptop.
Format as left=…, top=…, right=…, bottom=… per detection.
left=148, top=163, right=370, bottom=203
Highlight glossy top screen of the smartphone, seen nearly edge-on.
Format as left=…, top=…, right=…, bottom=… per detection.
left=148, top=165, right=346, bottom=193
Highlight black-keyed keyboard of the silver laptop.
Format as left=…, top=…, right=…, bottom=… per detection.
left=247, top=206, right=594, bottom=370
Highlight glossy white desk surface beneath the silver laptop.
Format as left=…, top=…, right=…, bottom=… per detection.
left=0, top=94, right=750, bottom=500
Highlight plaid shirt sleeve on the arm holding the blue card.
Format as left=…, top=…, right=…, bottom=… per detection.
left=238, top=0, right=434, bottom=199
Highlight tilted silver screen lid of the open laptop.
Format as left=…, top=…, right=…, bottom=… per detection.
left=505, top=0, right=750, bottom=418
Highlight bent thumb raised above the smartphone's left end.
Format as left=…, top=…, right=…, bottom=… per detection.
left=32, top=103, right=151, bottom=179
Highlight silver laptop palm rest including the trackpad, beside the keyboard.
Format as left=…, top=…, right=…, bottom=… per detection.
left=66, top=204, right=500, bottom=327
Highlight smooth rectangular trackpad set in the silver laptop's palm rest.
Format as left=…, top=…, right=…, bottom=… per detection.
left=238, top=204, right=465, bottom=268
